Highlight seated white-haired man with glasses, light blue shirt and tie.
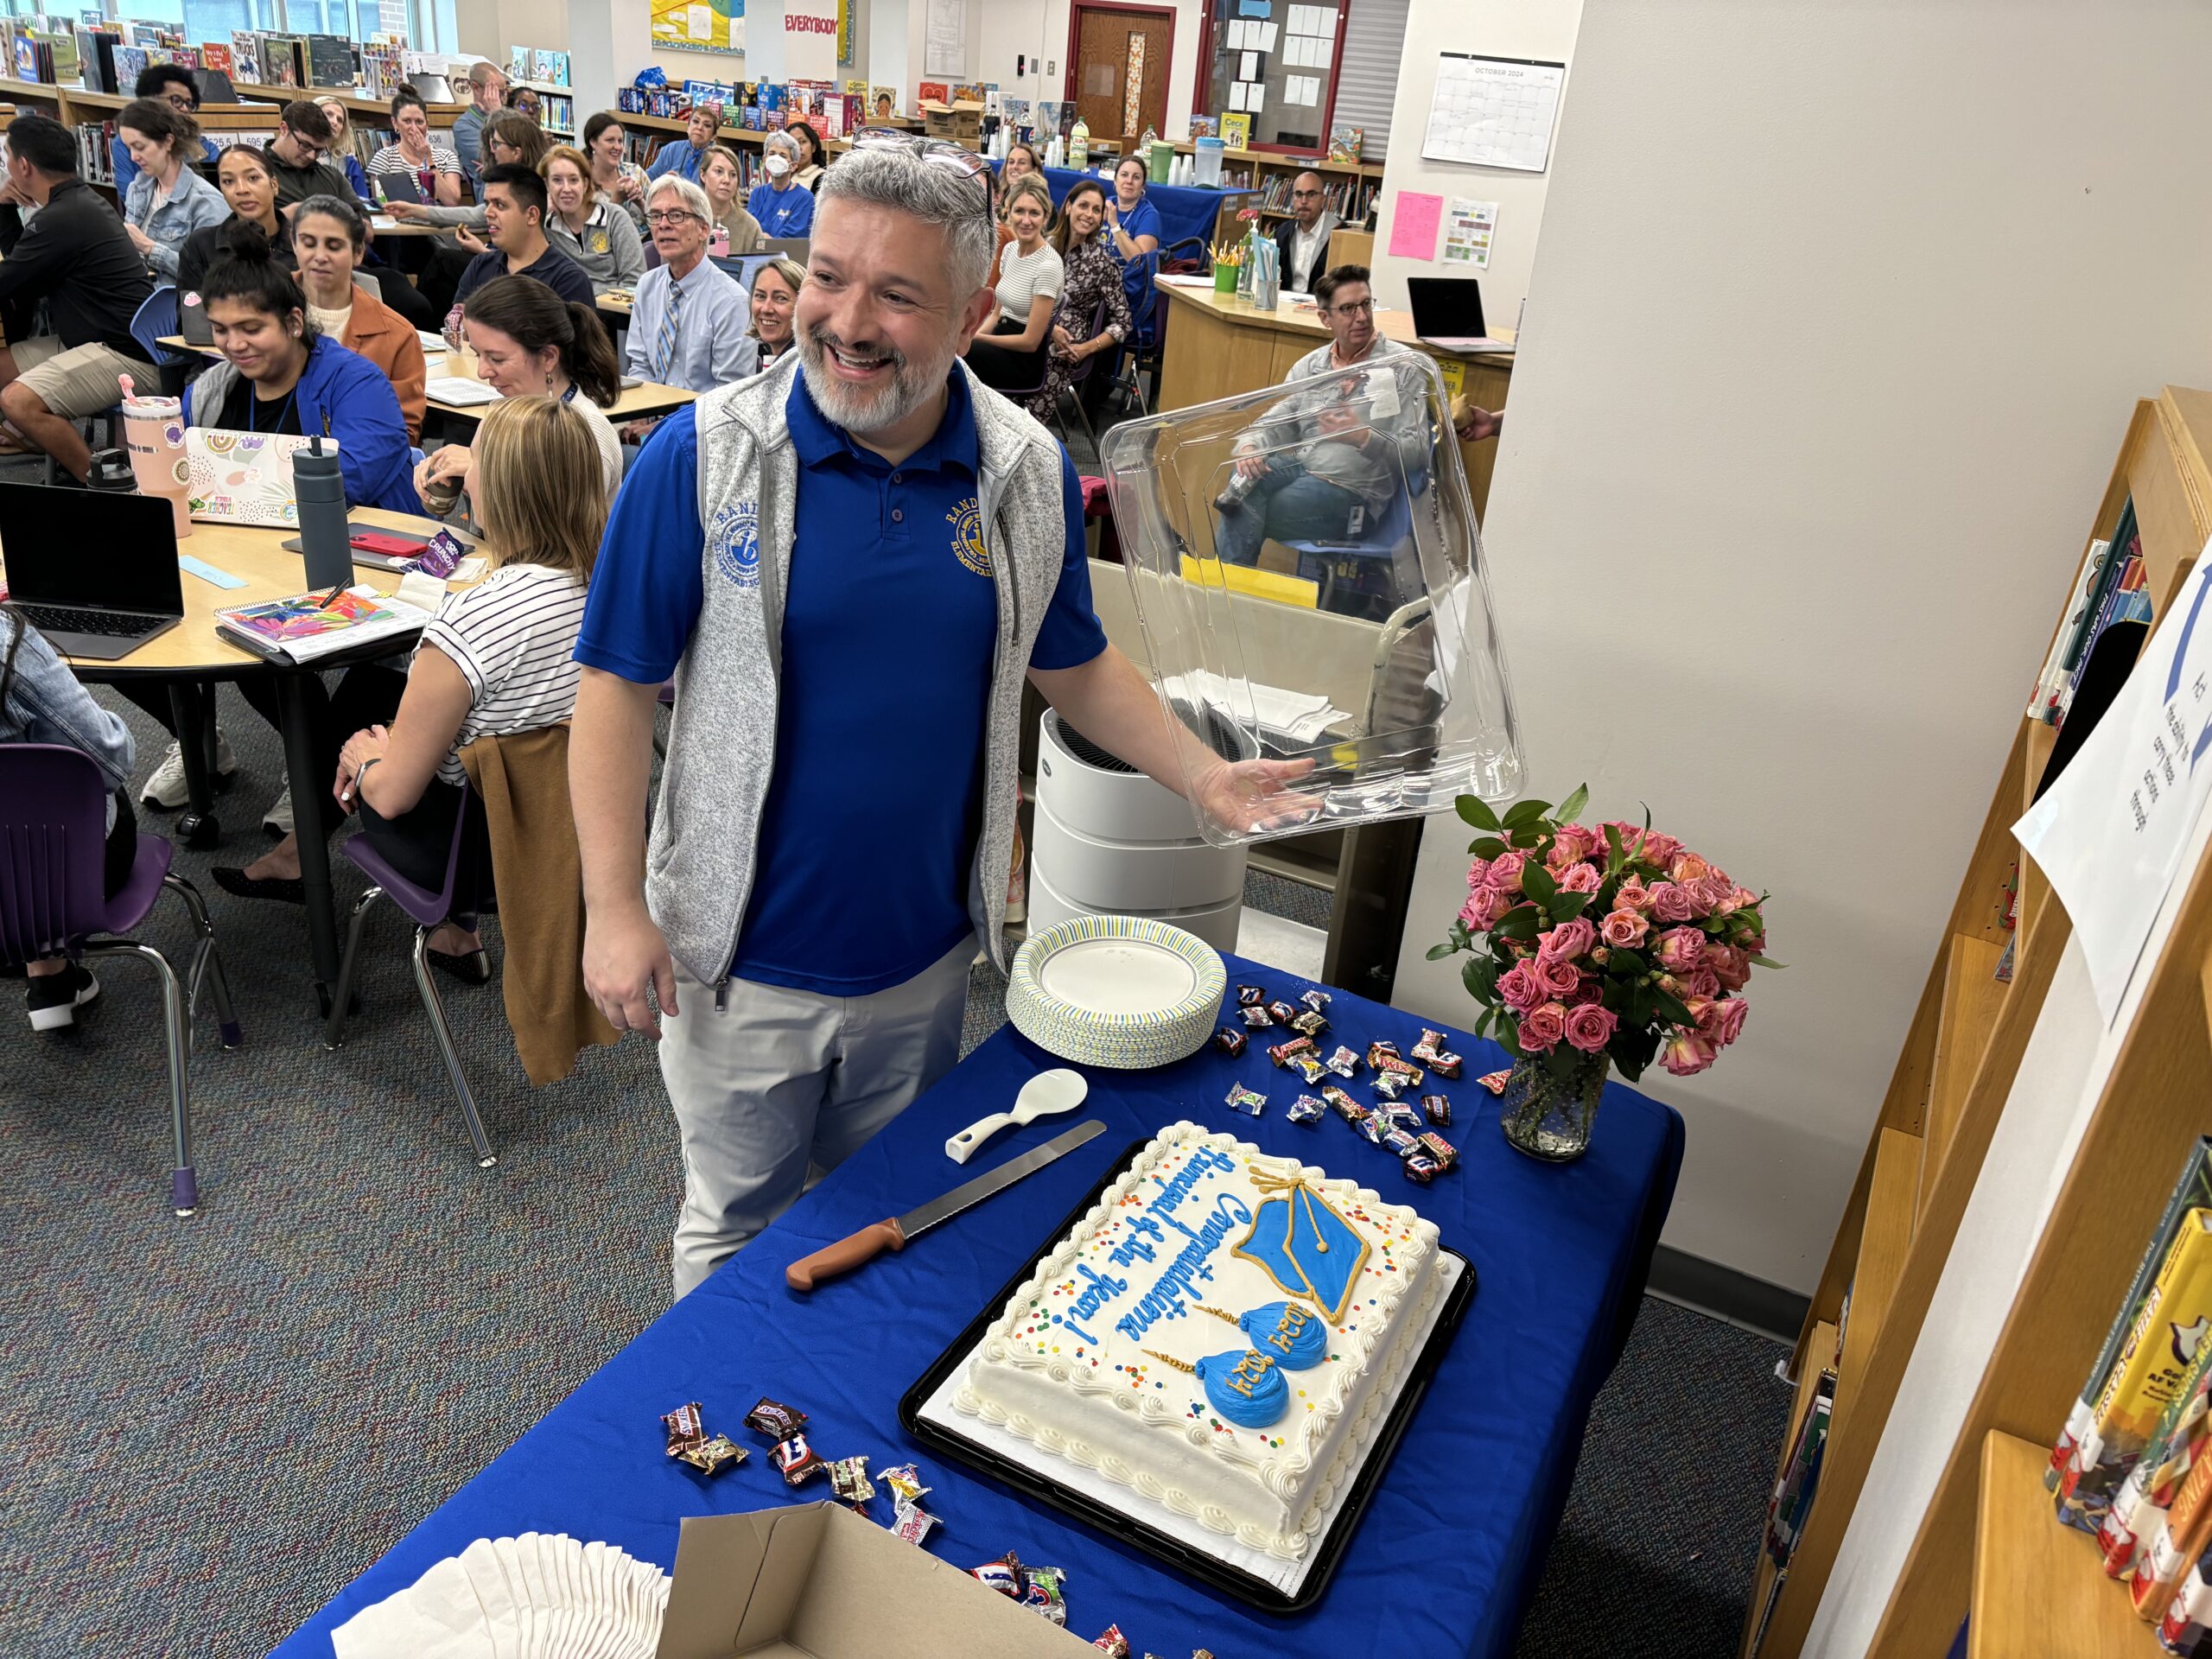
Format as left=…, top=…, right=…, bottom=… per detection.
left=621, top=177, right=761, bottom=391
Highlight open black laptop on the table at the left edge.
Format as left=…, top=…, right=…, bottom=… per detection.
left=0, top=485, right=183, bottom=661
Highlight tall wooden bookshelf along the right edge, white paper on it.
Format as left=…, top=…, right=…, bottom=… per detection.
left=1738, top=387, right=2212, bottom=1659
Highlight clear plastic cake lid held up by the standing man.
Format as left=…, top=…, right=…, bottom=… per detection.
left=1102, top=352, right=1522, bottom=847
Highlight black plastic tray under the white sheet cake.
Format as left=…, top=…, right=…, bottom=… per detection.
left=898, top=1139, right=1476, bottom=1615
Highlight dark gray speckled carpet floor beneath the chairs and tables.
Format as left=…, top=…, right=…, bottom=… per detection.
left=0, top=690, right=1787, bottom=1659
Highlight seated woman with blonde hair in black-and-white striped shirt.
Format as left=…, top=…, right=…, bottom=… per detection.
left=214, top=396, right=606, bottom=984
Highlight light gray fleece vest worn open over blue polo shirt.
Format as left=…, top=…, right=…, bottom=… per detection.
left=646, top=352, right=1066, bottom=987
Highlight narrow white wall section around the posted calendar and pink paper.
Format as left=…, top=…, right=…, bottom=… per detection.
left=1354, top=0, right=1581, bottom=327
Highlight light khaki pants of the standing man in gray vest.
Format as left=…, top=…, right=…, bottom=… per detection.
left=659, top=938, right=976, bottom=1296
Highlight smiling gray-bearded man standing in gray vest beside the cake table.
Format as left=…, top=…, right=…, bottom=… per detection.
left=569, top=133, right=1310, bottom=1296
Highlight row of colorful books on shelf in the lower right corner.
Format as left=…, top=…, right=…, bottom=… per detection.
left=2044, top=1137, right=2212, bottom=1655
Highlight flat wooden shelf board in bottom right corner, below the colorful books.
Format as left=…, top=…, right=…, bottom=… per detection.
left=1967, top=1433, right=2159, bottom=1659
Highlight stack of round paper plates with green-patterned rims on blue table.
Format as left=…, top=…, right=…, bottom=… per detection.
left=1007, top=916, right=1228, bottom=1068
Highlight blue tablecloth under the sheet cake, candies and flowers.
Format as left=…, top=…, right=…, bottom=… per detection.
left=263, top=957, right=1683, bottom=1659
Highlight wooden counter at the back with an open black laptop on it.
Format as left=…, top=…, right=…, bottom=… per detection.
left=1159, top=283, right=1513, bottom=515
